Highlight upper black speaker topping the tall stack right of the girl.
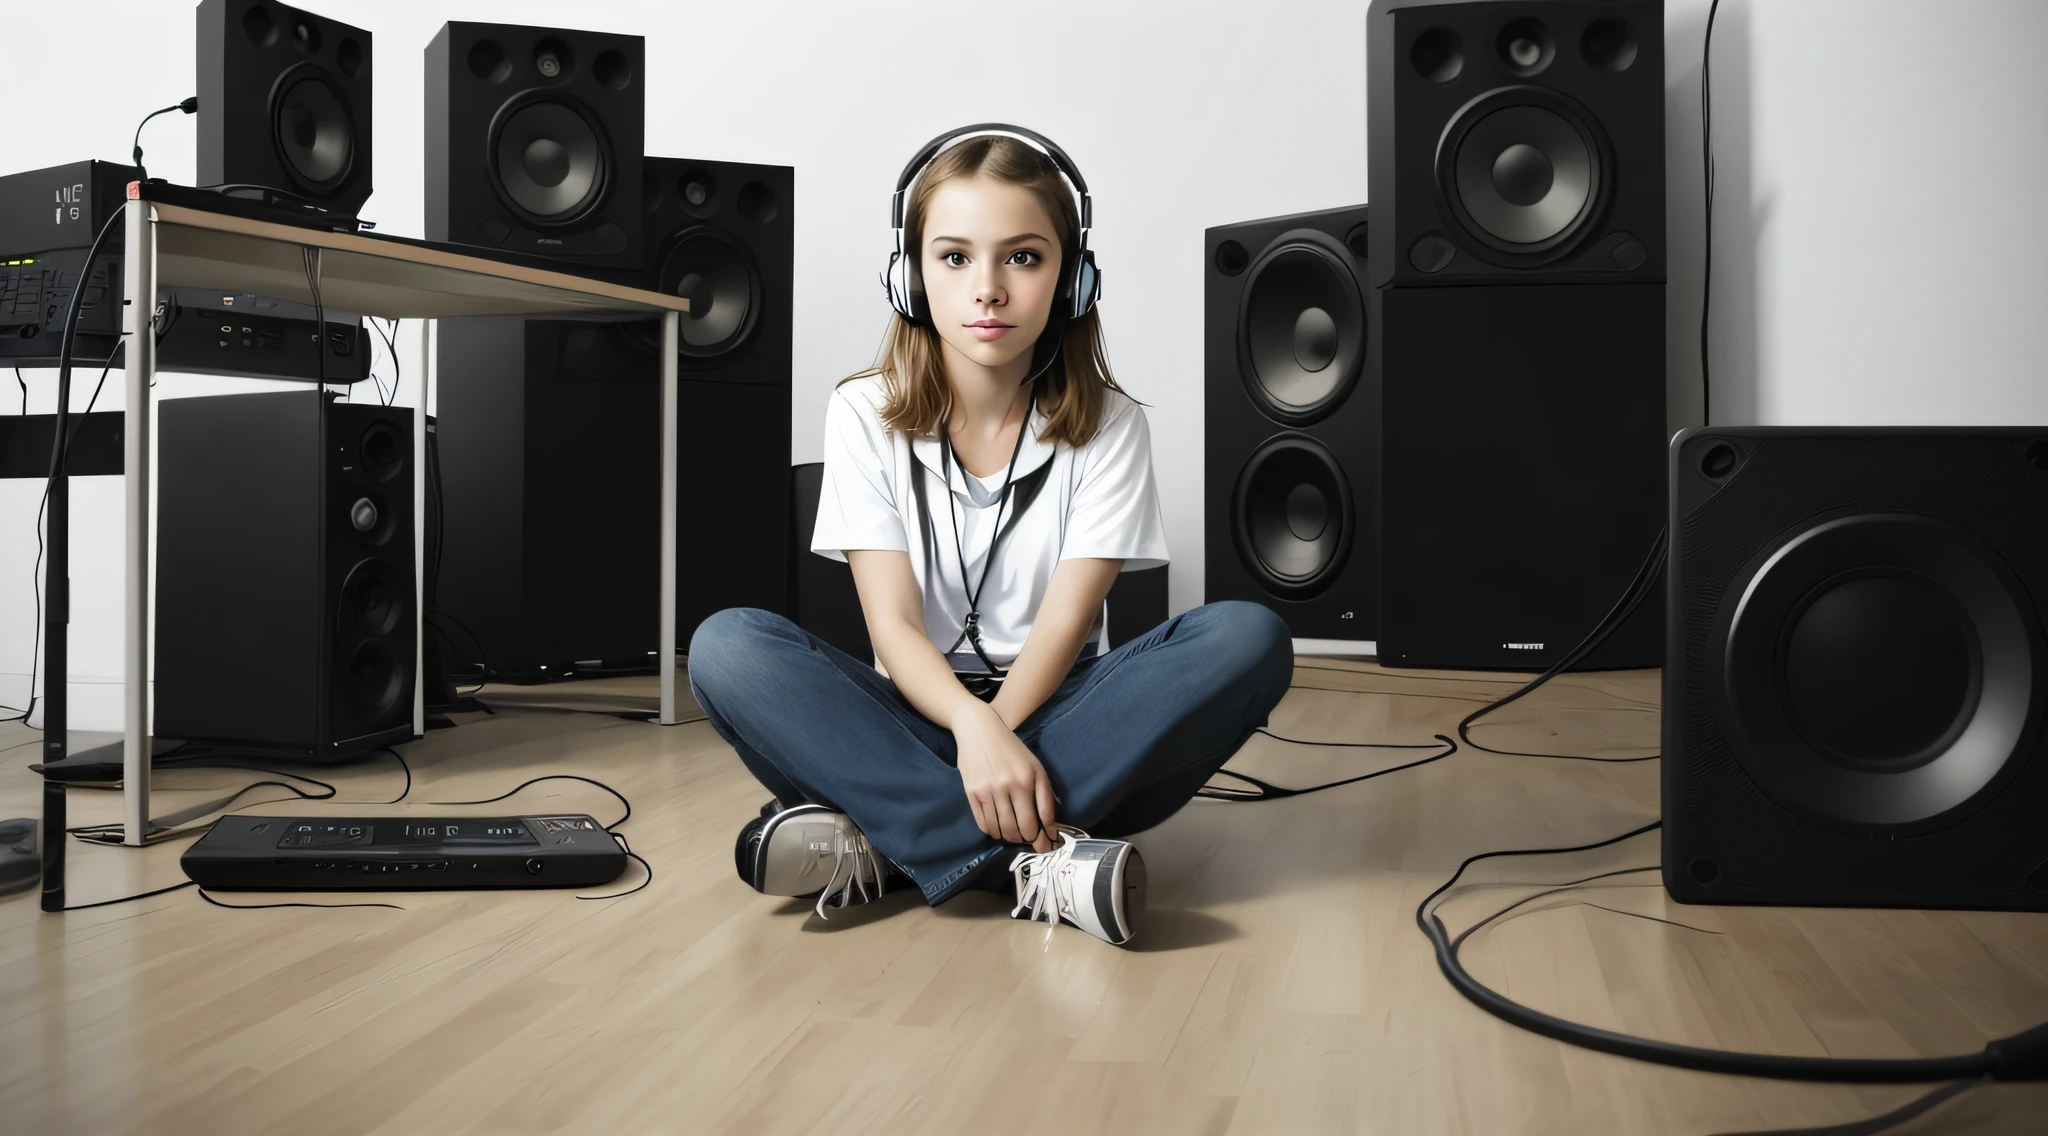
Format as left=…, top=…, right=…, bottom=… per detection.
left=1366, top=0, right=1665, bottom=287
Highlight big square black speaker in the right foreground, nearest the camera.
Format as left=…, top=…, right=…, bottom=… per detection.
left=1663, top=426, right=2048, bottom=911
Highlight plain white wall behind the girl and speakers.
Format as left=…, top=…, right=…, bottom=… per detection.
left=0, top=0, right=2048, bottom=727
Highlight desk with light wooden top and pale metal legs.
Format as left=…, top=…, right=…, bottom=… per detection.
left=43, top=184, right=690, bottom=911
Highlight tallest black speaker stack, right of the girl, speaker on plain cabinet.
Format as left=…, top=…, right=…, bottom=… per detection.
left=1366, top=0, right=1665, bottom=669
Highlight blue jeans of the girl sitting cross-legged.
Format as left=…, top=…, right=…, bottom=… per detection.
left=690, top=600, right=1294, bottom=905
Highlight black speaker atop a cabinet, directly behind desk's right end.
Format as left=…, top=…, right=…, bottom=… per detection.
left=639, top=158, right=797, bottom=376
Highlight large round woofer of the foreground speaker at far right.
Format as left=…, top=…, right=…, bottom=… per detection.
left=1708, top=514, right=2040, bottom=837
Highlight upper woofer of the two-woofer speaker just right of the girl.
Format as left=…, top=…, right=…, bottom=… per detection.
left=1237, top=229, right=1366, bottom=426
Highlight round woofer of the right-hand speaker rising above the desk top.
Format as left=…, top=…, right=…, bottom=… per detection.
left=489, top=92, right=610, bottom=225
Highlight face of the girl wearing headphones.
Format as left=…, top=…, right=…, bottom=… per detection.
left=920, top=176, right=1061, bottom=379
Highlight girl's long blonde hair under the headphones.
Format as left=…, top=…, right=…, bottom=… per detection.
left=840, top=135, right=1122, bottom=446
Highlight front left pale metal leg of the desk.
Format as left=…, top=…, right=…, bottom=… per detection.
left=121, top=201, right=156, bottom=845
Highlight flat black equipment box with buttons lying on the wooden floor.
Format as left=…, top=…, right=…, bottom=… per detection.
left=178, top=813, right=627, bottom=890
